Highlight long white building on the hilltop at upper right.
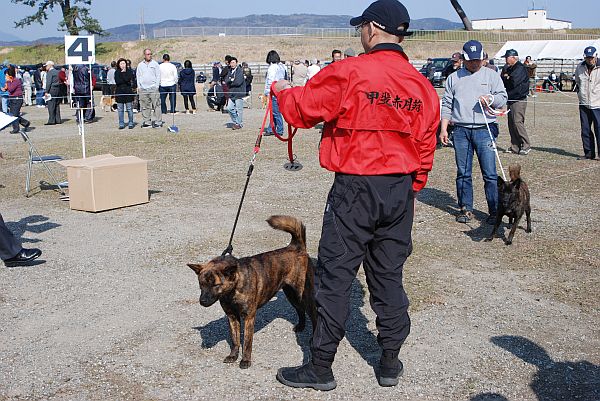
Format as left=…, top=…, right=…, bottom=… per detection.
left=471, top=10, right=573, bottom=30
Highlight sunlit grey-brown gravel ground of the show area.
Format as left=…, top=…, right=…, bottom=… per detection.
left=0, top=94, right=600, bottom=401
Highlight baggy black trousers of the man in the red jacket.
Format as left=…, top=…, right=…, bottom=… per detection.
left=311, top=174, right=414, bottom=366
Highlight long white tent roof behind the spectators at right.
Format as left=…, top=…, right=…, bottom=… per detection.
left=494, top=38, right=600, bottom=60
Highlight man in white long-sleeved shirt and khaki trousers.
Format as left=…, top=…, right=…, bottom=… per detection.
left=136, top=49, right=163, bottom=128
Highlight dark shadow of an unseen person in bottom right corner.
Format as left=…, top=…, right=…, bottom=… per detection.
left=471, top=336, right=600, bottom=401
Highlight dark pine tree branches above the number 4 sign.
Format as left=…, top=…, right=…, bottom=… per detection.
left=11, top=0, right=107, bottom=36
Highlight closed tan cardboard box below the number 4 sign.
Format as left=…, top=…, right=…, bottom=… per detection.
left=59, top=154, right=148, bottom=212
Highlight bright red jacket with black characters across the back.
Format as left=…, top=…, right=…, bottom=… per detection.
left=277, top=44, right=440, bottom=192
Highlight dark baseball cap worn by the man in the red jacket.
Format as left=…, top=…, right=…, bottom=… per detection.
left=350, top=0, right=413, bottom=36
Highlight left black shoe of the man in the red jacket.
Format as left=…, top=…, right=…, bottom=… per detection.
left=277, top=361, right=337, bottom=391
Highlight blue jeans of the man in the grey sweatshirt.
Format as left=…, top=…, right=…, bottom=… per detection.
left=453, top=124, right=498, bottom=215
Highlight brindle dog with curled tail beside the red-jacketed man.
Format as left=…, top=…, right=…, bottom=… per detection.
left=188, top=216, right=317, bottom=369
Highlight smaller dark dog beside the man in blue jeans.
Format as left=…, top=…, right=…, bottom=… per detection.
left=486, top=164, right=531, bottom=245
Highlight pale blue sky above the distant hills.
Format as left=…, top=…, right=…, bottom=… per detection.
left=0, top=0, right=600, bottom=40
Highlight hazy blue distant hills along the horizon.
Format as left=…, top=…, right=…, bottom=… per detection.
left=0, top=14, right=463, bottom=46
